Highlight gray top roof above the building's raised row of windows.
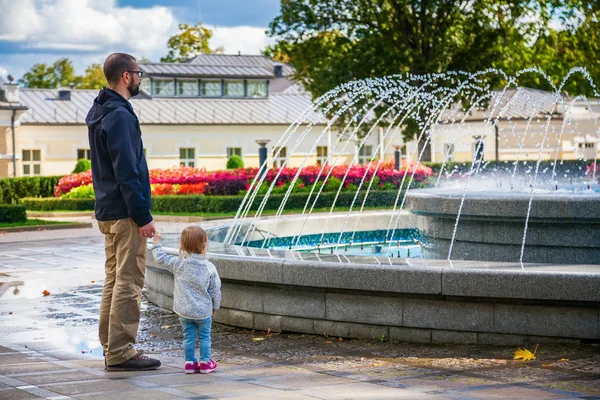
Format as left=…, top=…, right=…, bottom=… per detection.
left=140, top=54, right=294, bottom=79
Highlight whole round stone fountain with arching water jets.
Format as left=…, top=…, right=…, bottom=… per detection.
left=147, top=68, right=600, bottom=344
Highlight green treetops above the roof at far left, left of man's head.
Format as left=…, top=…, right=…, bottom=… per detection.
left=19, top=58, right=81, bottom=88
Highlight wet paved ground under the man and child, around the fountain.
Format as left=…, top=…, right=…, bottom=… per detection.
left=0, top=224, right=600, bottom=399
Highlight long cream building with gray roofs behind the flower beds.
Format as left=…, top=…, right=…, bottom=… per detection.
left=0, top=54, right=599, bottom=177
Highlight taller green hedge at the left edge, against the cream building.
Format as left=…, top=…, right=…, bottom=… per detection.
left=0, top=176, right=62, bottom=204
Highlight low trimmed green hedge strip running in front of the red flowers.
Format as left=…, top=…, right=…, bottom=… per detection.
left=21, top=191, right=404, bottom=213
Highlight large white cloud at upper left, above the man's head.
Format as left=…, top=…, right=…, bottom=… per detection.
left=0, top=0, right=177, bottom=57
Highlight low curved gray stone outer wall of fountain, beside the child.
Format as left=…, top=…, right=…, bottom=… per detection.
left=146, top=217, right=600, bottom=345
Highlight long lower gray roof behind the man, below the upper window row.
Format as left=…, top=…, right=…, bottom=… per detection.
left=16, top=89, right=317, bottom=125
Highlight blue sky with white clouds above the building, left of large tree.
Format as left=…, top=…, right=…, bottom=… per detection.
left=0, top=0, right=279, bottom=79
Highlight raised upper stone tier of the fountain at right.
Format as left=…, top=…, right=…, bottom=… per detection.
left=406, top=189, right=600, bottom=264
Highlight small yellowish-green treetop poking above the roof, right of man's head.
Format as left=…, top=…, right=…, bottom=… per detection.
left=160, top=22, right=223, bottom=62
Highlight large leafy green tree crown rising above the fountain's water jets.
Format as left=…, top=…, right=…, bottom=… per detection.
left=267, top=0, right=598, bottom=147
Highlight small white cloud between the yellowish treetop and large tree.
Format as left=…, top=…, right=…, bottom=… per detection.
left=209, top=26, right=275, bottom=54
